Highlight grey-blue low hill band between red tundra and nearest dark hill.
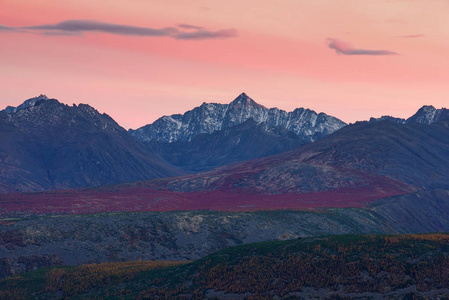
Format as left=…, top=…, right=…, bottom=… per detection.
left=0, top=190, right=449, bottom=278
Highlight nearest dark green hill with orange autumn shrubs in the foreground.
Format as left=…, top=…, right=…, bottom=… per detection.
left=0, top=234, right=449, bottom=299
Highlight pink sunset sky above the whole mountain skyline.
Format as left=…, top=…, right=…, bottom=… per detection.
left=0, top=0, right=449, bottom=128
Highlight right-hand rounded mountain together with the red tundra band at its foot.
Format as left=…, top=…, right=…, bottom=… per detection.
left=0, top=100, right=449, bottom=214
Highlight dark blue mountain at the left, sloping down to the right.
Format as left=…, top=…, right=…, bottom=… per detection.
left=0, top=95, right=181, bottom=192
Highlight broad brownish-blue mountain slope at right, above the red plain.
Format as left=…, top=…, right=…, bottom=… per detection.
left=153, top=117, right=449, bottom=194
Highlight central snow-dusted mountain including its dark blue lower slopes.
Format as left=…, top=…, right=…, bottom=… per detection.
left=130, top=93, right=346, bottom=173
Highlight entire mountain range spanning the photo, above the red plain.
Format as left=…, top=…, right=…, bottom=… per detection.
left=0, top=93, right=449, bottom=195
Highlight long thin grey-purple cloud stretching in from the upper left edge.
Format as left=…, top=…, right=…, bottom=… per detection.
left=0, top=20, right=237, bottom=40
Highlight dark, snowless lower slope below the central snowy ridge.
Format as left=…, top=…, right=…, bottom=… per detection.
left=146, top=119, right=310, bottom=173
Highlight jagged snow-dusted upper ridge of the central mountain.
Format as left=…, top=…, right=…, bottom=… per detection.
left=130, top=93, right=346, bottom=142
